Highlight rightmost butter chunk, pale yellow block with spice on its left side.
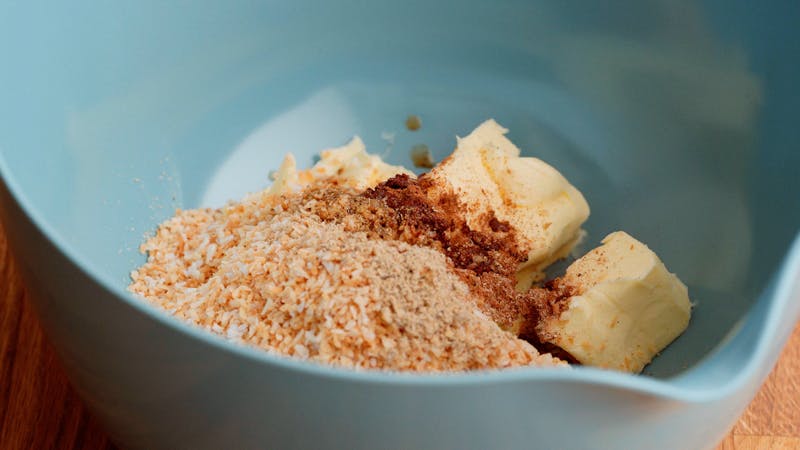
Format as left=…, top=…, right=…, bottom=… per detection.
left=537, top=231, right=691, bottom=373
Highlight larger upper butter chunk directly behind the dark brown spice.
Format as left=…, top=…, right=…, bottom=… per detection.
left=431, top=119, right=589, bottom=289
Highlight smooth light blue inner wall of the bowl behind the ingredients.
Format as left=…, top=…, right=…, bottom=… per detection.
left=0, top=1, right=800, bottom=378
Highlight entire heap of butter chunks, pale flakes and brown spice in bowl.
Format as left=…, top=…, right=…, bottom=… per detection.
left=129, top=120, right=690, bottom=372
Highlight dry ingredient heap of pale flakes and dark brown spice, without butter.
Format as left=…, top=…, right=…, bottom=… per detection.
left=130, top=180, right=564, bottom=372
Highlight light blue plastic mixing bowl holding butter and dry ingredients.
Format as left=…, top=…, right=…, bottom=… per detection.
left=0, top=0, right=800, bottom=449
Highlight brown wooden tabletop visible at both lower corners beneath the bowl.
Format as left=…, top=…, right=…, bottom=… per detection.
left=0, top=225, right=800, bottom=450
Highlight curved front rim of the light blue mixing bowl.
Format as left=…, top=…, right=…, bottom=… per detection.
left=0, top=148, right=800, bottom=403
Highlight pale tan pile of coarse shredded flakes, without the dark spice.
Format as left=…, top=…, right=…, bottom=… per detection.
left=130, top=188, right=562, bottom=371
